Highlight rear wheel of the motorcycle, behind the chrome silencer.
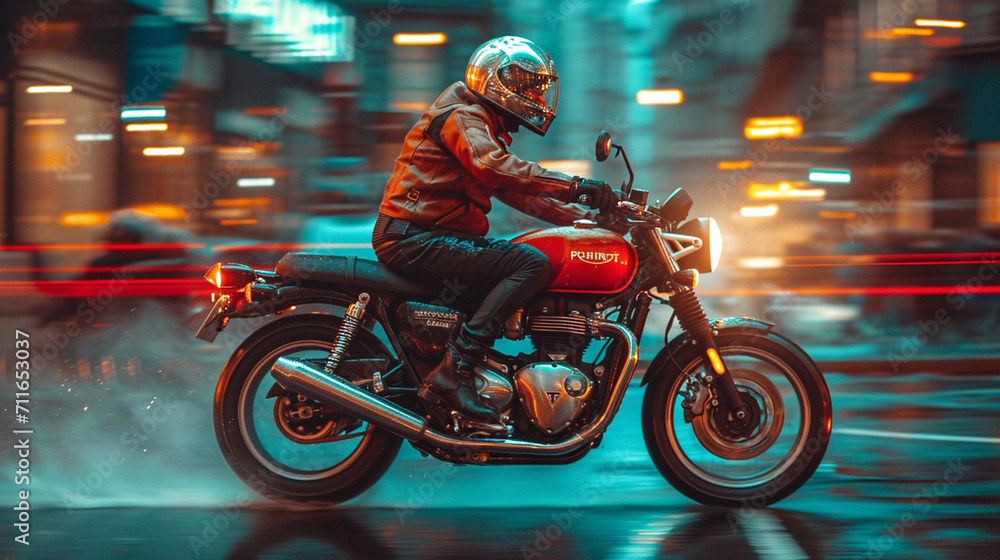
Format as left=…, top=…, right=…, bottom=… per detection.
left=214, top=315, right=402, bottom=503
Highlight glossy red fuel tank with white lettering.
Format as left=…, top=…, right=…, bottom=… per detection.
left=511, top=227, right=638, bottom=294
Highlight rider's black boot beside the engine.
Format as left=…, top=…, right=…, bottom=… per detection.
left=417, top=343, right=500, bottom=424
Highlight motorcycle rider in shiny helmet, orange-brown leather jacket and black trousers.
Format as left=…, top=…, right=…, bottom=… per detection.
left=372, top=36, right=618, bottom=422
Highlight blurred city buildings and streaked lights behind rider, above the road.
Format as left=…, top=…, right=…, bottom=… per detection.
left=0, top=0, right=1000, bottom=352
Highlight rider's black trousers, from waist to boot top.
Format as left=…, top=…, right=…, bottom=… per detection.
left=372, top=215, right=552, bottom=345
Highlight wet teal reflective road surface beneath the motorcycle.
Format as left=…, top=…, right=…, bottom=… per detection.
left=4, top=354, right=1000, bottom=559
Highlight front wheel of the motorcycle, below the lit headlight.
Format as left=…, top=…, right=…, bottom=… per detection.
left=642, top=329, right=832, bottom=508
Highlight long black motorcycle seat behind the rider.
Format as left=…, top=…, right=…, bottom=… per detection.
left=274, top=252, right=434, bottom=296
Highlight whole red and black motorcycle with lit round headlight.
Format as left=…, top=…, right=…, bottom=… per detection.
left=197, top=132, right=832, bottom=507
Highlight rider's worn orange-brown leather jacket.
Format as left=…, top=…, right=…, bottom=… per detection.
left=379, top=82, right=589, bottom=236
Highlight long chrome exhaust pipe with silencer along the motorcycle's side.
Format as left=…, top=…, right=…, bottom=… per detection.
left=271, top=321, right=639, bottom=456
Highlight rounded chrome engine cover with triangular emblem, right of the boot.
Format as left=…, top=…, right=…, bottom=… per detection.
left=514, top=362, right=593, bottom=434
